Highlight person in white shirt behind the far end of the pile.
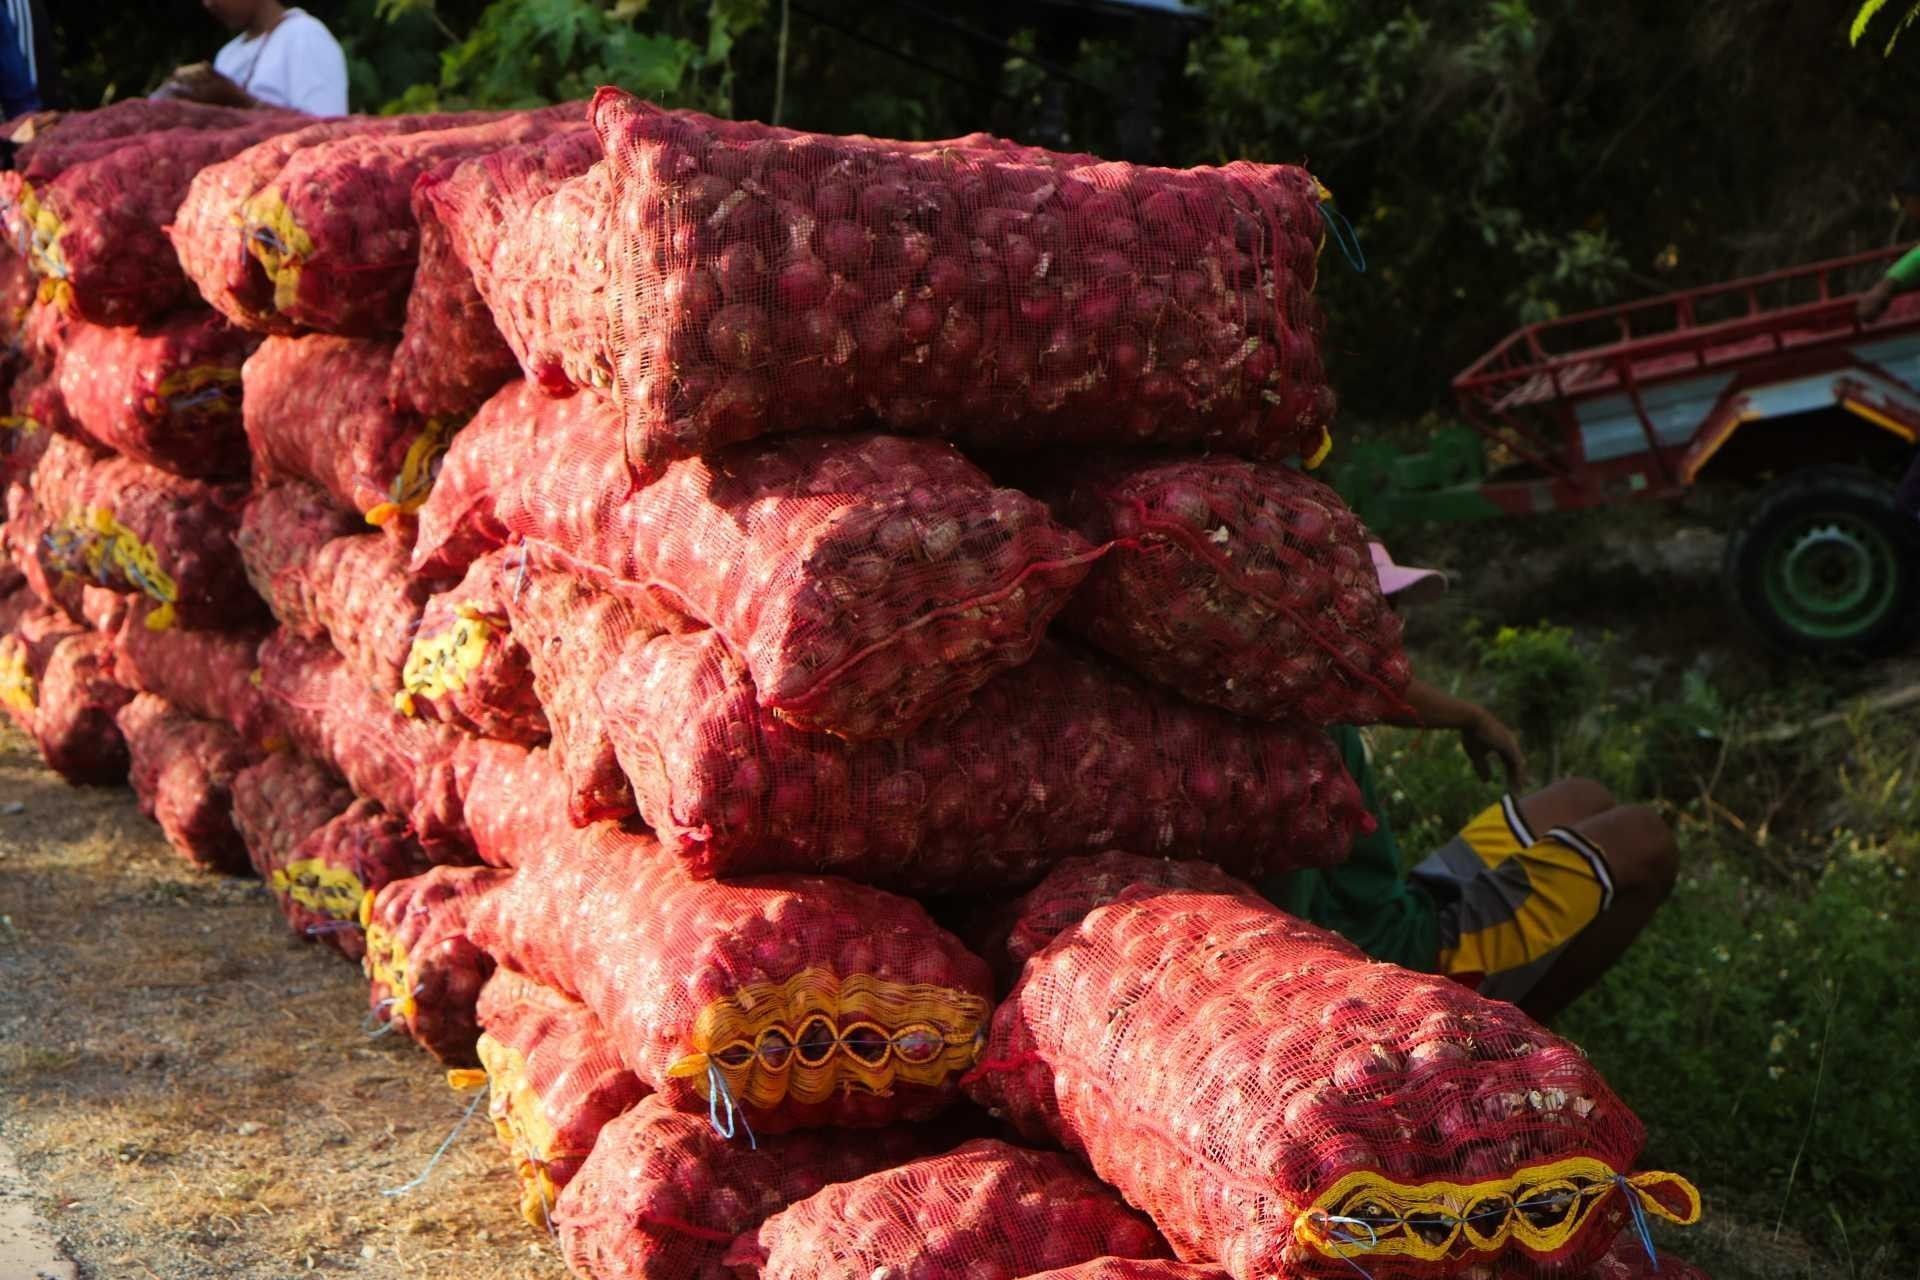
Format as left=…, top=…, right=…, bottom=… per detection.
left=154, top=0, right=348, bottom=115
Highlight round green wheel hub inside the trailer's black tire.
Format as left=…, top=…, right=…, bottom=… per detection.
left=1764, top=512, right=1899, bottom=639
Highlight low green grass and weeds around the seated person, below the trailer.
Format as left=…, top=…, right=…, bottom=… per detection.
left=1377, top=610, right=1920, bottom=1278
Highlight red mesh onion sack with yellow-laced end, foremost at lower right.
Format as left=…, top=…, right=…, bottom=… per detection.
left=972, top=889, right=1699, bottom=1280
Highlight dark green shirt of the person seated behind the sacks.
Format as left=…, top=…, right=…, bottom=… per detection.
left=1260, top=725, right=1440, bottom=973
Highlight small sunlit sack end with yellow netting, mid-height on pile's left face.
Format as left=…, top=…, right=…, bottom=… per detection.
left=396, top=551, right=547, bottom=747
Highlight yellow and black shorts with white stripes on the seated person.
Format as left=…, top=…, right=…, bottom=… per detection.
left=1409, top=796, right=1613, bottom=1004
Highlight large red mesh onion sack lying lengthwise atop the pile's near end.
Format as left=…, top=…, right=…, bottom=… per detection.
left=591, top=90, right=1332, bottom=474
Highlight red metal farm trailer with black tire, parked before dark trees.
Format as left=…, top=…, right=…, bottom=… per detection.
left=1336, top=249, right=1920, bottom=654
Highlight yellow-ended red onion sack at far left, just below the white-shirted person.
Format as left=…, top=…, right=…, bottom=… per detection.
left=21, top=115, right=294, bottom=324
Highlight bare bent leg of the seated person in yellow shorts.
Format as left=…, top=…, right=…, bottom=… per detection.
left=1519, top=804, right=1680, bottom=1023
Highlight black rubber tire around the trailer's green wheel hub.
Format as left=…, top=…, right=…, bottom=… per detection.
left=1724, top=466, right=1920, bottom=660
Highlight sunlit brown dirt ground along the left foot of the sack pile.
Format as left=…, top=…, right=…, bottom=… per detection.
left=0, top=729, right=566, bottom=1280
